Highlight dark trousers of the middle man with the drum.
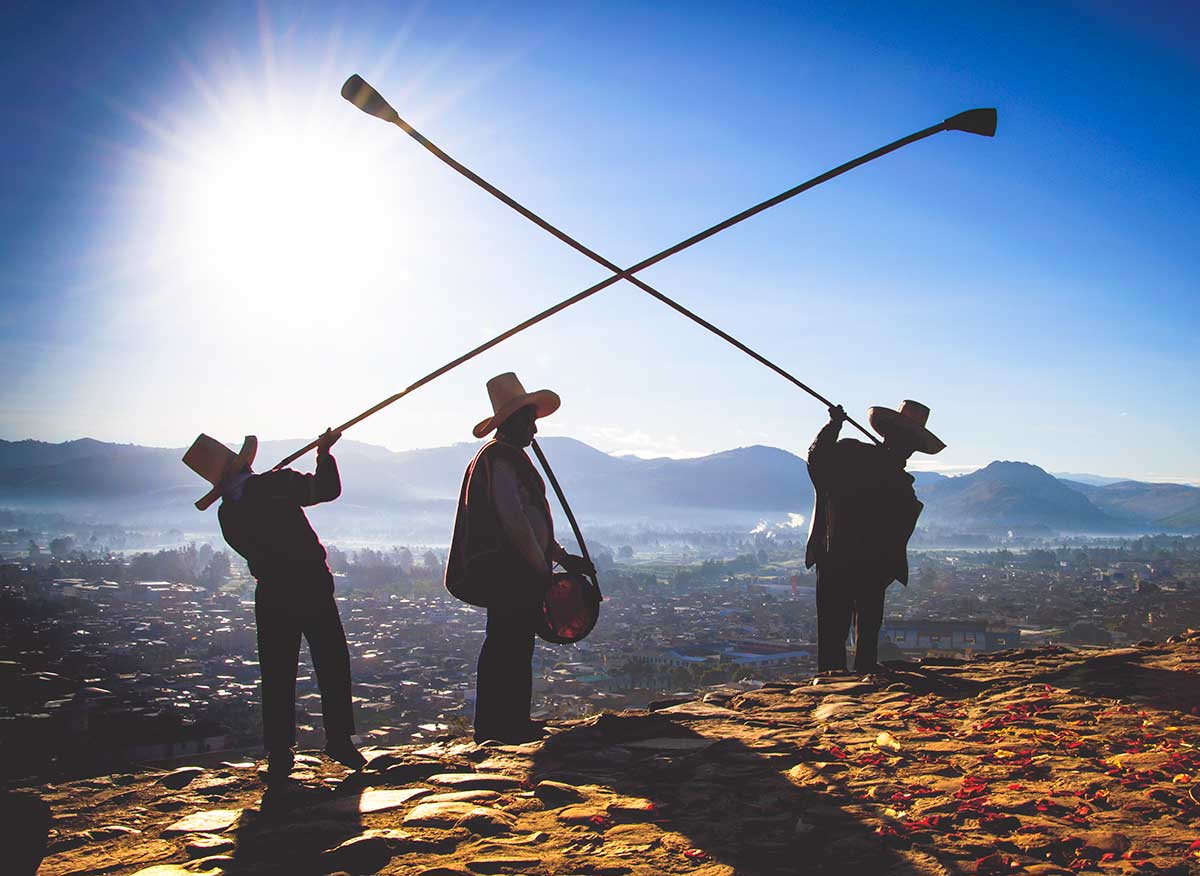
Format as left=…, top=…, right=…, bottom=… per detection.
left=475, top=607, right=534, bottom=739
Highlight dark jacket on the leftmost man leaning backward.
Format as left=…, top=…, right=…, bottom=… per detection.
left=217, top=454, right=342, bottom=593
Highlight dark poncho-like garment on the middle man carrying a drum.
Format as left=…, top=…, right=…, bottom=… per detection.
left=445, top=440, right=553, bottom=607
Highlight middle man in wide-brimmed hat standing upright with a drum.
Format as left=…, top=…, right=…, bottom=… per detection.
left=446, top=371, right=595, bottom=743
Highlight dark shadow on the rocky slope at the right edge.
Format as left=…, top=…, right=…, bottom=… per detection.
left=1031, top=650, right=1200, bottom=713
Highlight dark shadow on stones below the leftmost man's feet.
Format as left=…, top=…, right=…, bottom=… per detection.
left=223, top=776, right=360, bottom=876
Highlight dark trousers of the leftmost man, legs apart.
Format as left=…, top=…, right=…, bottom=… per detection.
left=254, top=584, right=354, bottom=751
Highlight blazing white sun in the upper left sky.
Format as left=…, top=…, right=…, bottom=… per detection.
left=146, top=91, right=403, bottom=318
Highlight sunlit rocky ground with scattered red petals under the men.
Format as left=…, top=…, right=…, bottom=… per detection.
left=21, top=632, right=1200, bottom=876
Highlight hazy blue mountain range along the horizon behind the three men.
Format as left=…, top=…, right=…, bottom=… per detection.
left=0, top=437, right=1200, bottom=534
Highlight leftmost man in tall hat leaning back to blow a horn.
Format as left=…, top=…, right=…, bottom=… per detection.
left=184, top=430, right=366, bottom=780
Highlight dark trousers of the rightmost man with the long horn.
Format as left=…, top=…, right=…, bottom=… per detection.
left=817, top=566, right=887, bottom=673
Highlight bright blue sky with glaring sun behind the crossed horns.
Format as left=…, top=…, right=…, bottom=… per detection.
left=0, top=0, right=1200, bottom=481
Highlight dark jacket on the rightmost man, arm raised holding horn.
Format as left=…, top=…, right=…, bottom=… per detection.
left=804, top=422, right=924, bottom=586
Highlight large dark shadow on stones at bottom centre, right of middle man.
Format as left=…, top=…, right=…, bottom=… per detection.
left=533, top=714, right=896, bottom=876
